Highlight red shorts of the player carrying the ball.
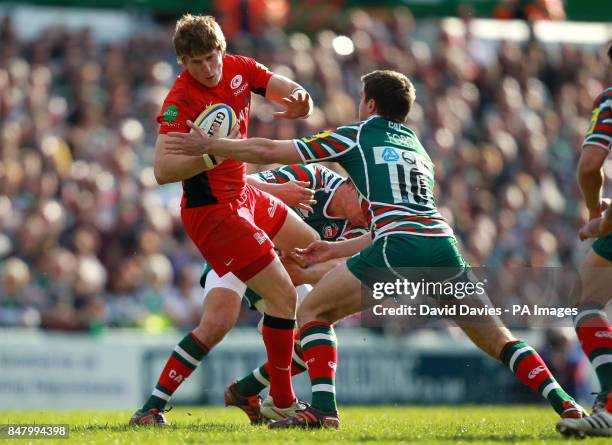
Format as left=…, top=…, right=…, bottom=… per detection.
left=181, top=184, right=288, bottom=281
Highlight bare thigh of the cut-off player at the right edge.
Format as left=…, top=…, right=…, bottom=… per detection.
left=580, top=245, right=612, bottom=305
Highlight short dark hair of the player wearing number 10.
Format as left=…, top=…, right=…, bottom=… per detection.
left=361, top=70, right=415, bottom=123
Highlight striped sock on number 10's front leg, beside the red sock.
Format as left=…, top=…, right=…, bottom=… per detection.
left=300, top=321, right=338, bottom=411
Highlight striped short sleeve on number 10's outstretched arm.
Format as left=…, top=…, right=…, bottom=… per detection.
left=293, top=125, right=359, bottom=163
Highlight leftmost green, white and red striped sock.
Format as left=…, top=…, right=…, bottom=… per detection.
left=142, top=332, right=208, bottom=411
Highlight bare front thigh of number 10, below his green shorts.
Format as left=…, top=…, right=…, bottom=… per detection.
left=298, top=263, right=363, bottom=326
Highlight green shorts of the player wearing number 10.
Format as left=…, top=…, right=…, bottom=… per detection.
left=347, top=235, right=469, bottom=289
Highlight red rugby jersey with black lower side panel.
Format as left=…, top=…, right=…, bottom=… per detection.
left=157, top=54, right=272, bottom=207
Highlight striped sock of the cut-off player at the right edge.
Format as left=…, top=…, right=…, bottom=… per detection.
left=574, top=304, right=612, bottom=391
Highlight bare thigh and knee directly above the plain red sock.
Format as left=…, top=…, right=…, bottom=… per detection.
left=246, top=257, right=297, bottom=318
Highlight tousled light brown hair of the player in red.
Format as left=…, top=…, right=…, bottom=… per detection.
left=174, top=14, right=227, bottom=63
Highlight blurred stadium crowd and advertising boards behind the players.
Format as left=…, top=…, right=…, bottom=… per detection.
left=0, top=0, right=612, bottom=409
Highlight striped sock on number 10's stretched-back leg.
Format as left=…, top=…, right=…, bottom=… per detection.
left=500, top=340, right=574, bottom=414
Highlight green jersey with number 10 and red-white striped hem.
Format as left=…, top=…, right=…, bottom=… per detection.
left=293, top=116, right=453, bottom=239
